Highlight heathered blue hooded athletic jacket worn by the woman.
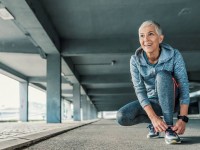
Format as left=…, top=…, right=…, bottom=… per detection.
left=130, top=43, right=190, bottom=107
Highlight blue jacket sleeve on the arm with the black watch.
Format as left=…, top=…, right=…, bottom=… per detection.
left=174, top=50, right=190, bottom=105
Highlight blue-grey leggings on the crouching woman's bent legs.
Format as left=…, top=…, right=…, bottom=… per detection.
left=117, top=71, right=179, bottom=126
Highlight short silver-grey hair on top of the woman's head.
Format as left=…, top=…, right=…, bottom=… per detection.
left=138, top=20, right=163, bottom=35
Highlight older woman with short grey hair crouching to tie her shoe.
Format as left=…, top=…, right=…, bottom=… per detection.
left=117, top=20, right=190, bottom=144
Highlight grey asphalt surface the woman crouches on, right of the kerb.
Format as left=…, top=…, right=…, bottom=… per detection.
left=22, top=115, right=200, bottom=150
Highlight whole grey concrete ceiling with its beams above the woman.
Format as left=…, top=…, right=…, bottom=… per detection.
left=0, top=0, right=200, bottom=111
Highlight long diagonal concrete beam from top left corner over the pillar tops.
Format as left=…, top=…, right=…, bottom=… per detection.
left=1, top=0, right=92, bottom=105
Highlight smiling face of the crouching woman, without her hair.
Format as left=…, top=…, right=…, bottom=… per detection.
left=139, top=25, right=164, bottom=53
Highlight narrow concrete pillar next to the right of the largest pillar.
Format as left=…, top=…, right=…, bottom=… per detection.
left=73, top=83, right=81, bottom=121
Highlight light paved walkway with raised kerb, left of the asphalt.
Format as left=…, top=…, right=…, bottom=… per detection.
left=0, top=120, right=97, bottom=150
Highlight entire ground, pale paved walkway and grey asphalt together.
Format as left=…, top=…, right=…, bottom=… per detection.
left=0, top=115, right=200, bottom=150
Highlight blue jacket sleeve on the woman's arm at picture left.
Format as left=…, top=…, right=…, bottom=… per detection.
left=130, top=56, right=150, bottom=108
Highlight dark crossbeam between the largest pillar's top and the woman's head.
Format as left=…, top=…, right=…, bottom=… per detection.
left=61, top=38, right=136, bottom=56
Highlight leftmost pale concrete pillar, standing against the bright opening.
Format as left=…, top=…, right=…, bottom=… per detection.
left=19, top=82, right=28, bottom=122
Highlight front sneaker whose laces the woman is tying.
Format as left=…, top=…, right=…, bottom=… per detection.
left=165, top=127, right=181, bottom=144
